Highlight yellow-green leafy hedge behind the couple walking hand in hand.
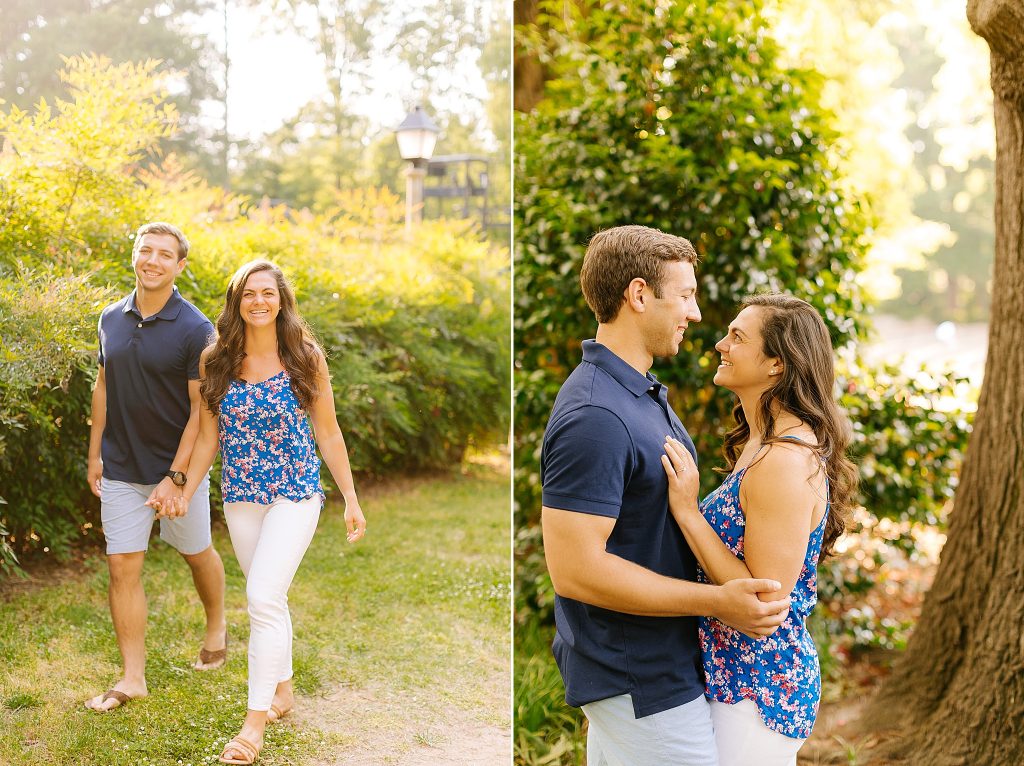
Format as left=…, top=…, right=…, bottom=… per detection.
left=0, top=57, right=510, bottom=568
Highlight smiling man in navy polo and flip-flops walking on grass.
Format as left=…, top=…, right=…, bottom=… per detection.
left=85, top=222, right=227, bottom=713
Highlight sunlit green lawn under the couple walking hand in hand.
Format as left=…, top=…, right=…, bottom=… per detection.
left=0, top=460, right=510, bottom=766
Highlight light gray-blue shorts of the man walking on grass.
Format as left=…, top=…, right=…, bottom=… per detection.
left=100, top=475, right=213, bottom=556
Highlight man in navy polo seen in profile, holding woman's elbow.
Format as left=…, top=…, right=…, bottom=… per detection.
left=541, top=226, right=788, bottom=766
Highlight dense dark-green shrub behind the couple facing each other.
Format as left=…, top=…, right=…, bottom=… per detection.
left=514, top=0, right=969, bottom=611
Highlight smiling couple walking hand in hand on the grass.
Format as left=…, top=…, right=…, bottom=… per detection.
left=85, top=222, right=366, bottom=764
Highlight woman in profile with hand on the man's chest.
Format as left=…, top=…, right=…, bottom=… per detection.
left=663, top=295, right=856, bottom=766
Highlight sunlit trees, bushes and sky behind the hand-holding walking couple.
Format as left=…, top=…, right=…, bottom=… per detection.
left=0, top=0, right=511, bottom=573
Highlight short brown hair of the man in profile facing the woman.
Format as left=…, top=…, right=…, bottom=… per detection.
left=580, top=225, right=697, bottom=324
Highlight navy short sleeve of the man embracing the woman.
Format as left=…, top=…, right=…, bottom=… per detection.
left=541, top=406, right=636, bottom=518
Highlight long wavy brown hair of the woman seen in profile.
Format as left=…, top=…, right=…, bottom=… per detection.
left=723, top=293, right=858, bottom=558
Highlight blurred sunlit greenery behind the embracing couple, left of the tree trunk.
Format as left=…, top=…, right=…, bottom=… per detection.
left=513, top=0, right=978, bottom=764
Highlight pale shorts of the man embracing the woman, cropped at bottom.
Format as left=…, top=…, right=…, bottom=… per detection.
left=583, top=694, right=718, bottom=766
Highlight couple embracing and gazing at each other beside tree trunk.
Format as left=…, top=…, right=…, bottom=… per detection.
left=541, top=226, right=856, bottom=766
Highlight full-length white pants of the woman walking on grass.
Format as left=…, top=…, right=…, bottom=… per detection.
left=224, top=495, right=322, bottom=710
